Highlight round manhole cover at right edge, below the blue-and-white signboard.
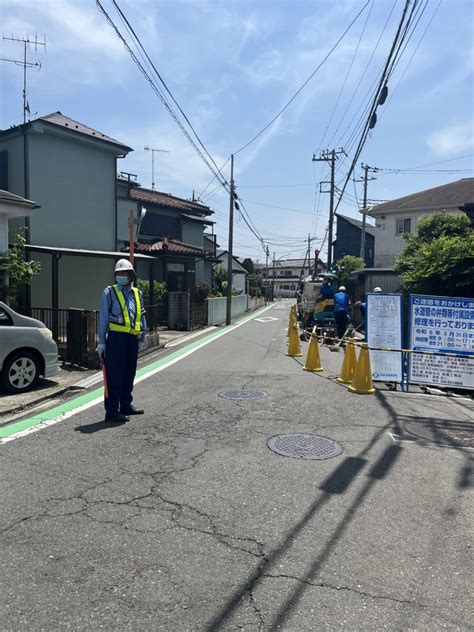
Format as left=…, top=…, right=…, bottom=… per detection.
left=403, top=419, right=474, bottom=448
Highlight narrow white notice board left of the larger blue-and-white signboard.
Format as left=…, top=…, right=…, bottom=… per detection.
left=365, top=293, right=403, bottom=382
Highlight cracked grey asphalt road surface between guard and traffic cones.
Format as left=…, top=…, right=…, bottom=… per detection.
left=0, top=305, right=474, bottom=632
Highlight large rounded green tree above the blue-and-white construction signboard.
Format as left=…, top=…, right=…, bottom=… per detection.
left=395, top=212, right=474, bottom=298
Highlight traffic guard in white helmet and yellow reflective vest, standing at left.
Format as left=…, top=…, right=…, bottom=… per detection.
left=97, top=259, right=146, bottom=422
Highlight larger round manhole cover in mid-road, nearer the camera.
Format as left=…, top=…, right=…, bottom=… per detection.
left=267, top=432, right=342, bottom=461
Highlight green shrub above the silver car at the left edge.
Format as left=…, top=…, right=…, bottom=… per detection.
left=0, top=231, right=41, bottom=303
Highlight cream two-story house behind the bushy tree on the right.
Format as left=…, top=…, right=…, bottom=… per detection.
left=369, top=178, right=474, bottom=268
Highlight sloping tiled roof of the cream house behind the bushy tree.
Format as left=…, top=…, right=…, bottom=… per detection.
left=370, top=178, right=474, bottom=215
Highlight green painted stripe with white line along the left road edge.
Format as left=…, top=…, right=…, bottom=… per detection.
left=0, top=303, right=273, bottom=439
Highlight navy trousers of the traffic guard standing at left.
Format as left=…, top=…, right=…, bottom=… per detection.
left=104, top=331, right=138, bottom=415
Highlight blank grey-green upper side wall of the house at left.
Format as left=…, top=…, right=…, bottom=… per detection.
left=28, top=126, right=115, bottom=250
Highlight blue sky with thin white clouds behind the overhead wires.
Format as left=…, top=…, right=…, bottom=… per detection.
left=0, top=0, right=474, bottom=260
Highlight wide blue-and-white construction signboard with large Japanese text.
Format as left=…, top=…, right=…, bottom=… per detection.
left=409, top=294, right=474, bottom=389
